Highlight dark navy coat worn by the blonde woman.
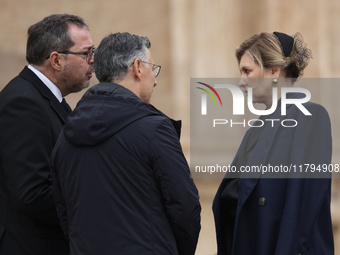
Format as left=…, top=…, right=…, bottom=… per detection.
left=213, top=94, right=334, bottom=255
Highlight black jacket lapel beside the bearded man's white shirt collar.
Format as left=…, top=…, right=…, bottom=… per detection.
left=20, top=67, right=68, bottom=124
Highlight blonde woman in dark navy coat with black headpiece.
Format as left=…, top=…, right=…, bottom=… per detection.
left=213, top=32, right=333, bottom=255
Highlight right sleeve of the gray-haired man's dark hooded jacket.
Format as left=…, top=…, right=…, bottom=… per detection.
left=151, top=119, right=201, bottom=255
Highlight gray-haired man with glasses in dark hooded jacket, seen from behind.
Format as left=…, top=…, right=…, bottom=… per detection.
left=52, top=33, right=201, bottom=255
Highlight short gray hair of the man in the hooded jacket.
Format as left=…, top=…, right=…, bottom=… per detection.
left=94, top=33, right=151, bottom=82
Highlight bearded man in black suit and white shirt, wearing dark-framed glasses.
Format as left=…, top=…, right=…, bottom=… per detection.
left=0, top=14, right=94, bottom=255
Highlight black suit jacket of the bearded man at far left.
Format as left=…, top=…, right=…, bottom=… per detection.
left=0, top=67, right=68, bottom=255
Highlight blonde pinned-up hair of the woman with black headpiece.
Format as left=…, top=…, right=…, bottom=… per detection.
left=236, top=33, right=312, bottom=82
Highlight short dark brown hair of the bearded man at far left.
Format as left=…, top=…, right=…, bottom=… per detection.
left=26, top=14, right=89, bottom=66
